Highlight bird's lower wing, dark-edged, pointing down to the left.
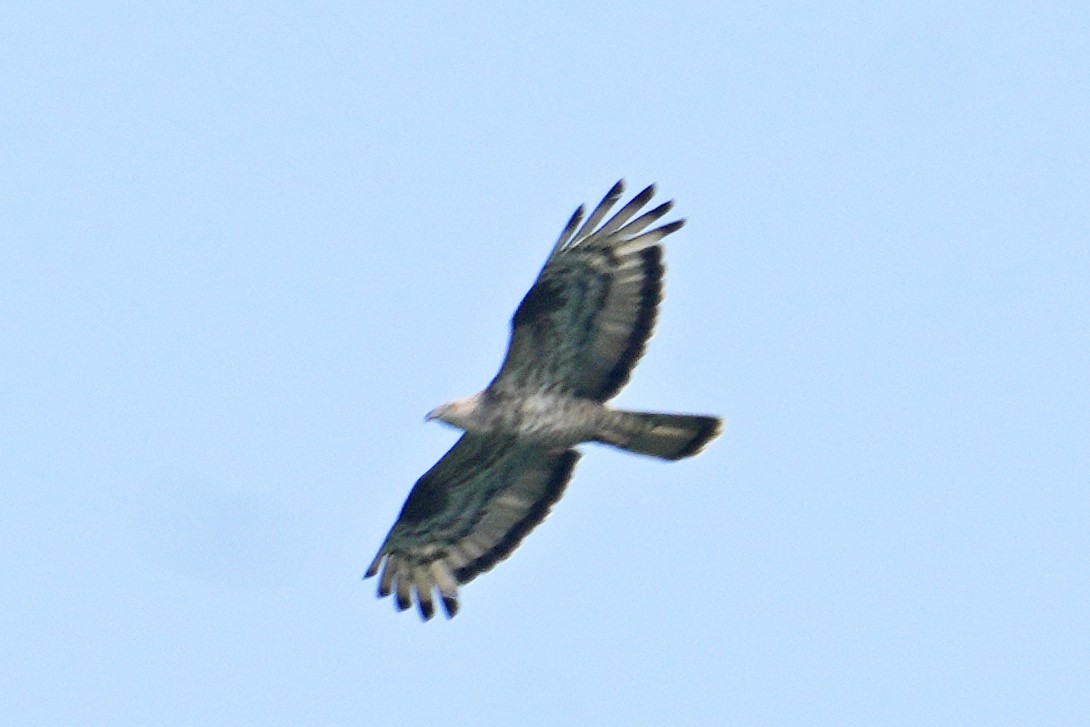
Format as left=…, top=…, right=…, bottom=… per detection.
left=364, top=434, right=579, bottom=620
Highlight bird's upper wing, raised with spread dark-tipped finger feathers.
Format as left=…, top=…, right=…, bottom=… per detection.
left=491, top=181, right=685, bottom=401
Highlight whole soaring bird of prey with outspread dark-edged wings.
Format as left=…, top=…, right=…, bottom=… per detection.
left=364, top=180, right=722, bottom=620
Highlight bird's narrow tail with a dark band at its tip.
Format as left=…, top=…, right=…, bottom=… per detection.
left=596, top=411, right=723, bottom=460
